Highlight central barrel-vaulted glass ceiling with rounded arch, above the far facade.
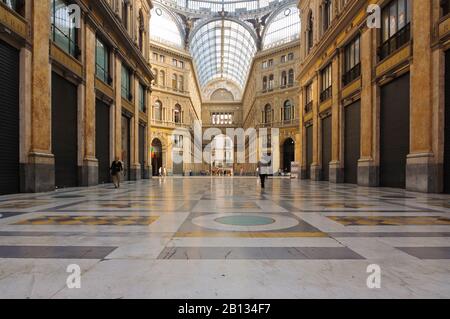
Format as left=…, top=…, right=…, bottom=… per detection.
left=190, top=19, right=256, bottom=88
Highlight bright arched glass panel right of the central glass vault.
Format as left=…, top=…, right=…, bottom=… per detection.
left=263, top=6, right=301, bottom=49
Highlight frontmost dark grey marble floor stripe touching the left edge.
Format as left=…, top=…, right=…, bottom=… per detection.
left=0, top=246, right=117, bottom=259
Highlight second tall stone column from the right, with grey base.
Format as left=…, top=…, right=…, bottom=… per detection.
left=358, top=27, right=379, bottom=187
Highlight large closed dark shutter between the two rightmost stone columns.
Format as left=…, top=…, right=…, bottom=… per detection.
left=380, top=74, right=410, bottom=188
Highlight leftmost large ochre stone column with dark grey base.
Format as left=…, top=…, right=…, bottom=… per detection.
left=21, top=0, right=55, bottom=192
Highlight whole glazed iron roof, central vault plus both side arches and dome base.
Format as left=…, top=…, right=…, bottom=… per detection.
left=150, top=0, right=300, bottom=89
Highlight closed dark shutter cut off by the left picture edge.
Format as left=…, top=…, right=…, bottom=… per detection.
left=0, top=41, right=20, bottom=195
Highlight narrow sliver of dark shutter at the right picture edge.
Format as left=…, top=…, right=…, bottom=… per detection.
left=444, top=51, right=450, bottom=194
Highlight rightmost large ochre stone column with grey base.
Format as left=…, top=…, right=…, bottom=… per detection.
left=406, top=1, right=442, bottom=193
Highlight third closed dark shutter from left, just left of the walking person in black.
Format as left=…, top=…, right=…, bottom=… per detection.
left=95, top=100, right=112, bottom=184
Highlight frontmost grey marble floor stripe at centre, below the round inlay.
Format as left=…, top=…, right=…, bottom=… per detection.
left=158, top=247, right=364, bottom=260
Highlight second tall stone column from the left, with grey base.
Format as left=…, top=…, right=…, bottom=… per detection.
left=79, top=24, right=98, bottom=186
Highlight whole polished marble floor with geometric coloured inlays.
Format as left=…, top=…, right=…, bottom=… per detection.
left=0, top=177, right=450, bottom=299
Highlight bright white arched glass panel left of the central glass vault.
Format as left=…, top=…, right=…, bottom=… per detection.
left=150, top=6, right=184, bottom=48
